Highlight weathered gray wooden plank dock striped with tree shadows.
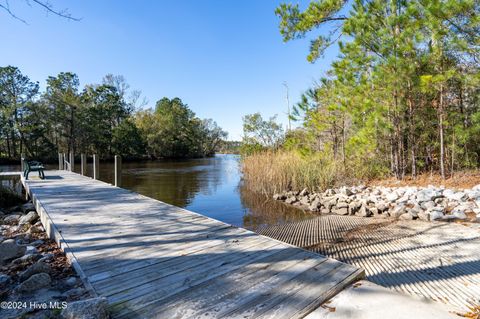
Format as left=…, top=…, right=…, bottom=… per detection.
left=22, top=171, right=363, bottom=318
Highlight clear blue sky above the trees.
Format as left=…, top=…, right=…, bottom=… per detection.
left=0, top=0, right=337, bottom=140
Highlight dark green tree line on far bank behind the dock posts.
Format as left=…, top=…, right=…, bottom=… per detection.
left=0, top=66, right=227, bottom=160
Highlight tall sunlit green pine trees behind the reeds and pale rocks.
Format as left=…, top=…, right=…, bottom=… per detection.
left=276, top=0, right=480, bottom=178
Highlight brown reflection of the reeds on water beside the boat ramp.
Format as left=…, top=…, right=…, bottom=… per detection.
left=239, top=184, right=315, bottom=231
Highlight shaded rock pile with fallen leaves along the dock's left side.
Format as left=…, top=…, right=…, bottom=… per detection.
left=0, top=202, right=108, bottom=319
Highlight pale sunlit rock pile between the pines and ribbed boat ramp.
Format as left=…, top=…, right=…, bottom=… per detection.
left=273, top=185, right=480, bottom=221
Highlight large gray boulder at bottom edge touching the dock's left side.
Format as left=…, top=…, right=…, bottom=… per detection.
left=61, top=298, right=109, bottom=319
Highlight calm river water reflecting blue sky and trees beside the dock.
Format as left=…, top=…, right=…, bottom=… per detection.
left=0, top=155, right=312, bottom=230
